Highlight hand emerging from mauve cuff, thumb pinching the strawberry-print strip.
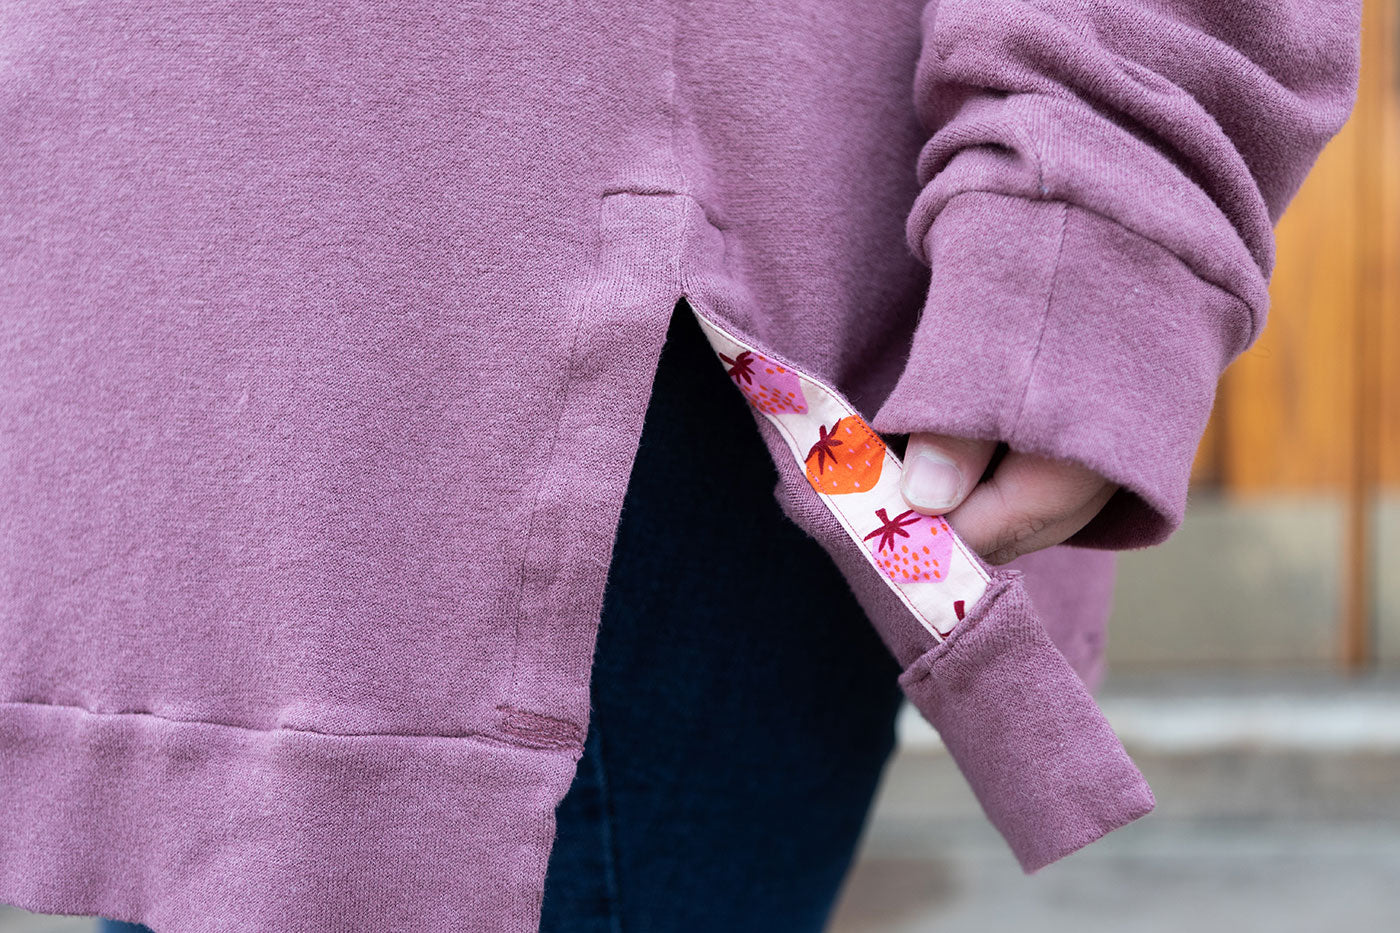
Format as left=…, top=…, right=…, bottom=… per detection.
left=902, top=434, right=1117, bottom=565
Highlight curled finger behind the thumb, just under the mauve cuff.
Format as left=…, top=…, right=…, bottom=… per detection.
left=946, top=451, right=1117, bottom=565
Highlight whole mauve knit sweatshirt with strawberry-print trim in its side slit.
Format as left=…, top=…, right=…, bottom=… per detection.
left=0, top=0, right=1361, bottom=933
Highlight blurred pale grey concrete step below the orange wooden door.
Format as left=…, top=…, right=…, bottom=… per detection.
left=832, top=674, right=1400, bottom=933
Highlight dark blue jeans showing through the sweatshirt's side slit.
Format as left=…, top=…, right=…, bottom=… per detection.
left=108, top=304, right=900, bottom=933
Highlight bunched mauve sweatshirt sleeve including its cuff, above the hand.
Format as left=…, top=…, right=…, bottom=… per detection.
left=871, top=0, right=1361, bottom=548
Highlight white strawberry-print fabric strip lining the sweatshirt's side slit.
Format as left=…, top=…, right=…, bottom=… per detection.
left=687, top=300, right=990, bottom=640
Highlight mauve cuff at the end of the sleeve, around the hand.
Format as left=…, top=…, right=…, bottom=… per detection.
left=871, top=191, right=1252, bottom=548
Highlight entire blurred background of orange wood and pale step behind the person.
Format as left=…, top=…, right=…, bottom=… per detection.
left=0, top=0, right=1400, bottom=933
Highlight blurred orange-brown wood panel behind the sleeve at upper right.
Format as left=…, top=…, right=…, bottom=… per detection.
left=1193, top=0, right=1400, bottom=495
